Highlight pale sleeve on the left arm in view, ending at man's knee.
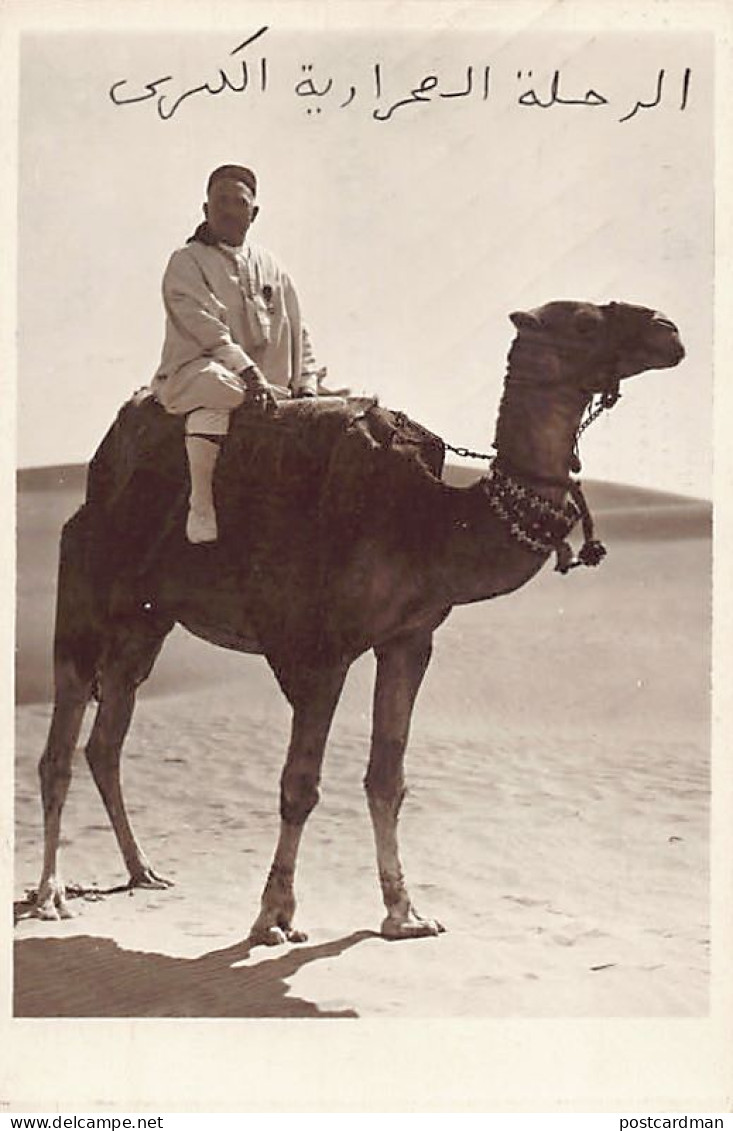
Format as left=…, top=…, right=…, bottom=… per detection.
left=163, top=248, right=255, bottom=373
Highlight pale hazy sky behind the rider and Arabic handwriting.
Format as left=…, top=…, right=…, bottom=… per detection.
left=18, top=6, right=714, bottom=495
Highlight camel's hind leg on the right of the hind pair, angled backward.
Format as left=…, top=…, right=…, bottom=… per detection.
left=86, top=612, right=172, bottom=888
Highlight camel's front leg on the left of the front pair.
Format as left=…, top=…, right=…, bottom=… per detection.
left=250, top=666, right=346, bottom=946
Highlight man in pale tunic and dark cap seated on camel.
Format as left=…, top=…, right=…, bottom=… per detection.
left=152, top=165, right=324, bottom=543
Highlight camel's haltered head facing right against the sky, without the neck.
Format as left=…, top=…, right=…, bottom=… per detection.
left=509, top=302, right=684, bottom=394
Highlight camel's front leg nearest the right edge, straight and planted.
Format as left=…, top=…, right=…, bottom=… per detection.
left=364, top=632, right=443, bottom=939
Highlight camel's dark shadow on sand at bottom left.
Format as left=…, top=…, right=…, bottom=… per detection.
left=14, top=931, right=379, bottom=1017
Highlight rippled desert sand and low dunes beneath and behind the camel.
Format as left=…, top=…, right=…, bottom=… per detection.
left=15, top=459, right=712, bottom=1018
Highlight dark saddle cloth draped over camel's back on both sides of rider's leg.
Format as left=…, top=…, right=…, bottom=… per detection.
left=85, top=389, right=445, bottom=572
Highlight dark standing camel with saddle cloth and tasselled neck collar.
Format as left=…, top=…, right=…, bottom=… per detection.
left=36, top=301, right=684, bottom=944
